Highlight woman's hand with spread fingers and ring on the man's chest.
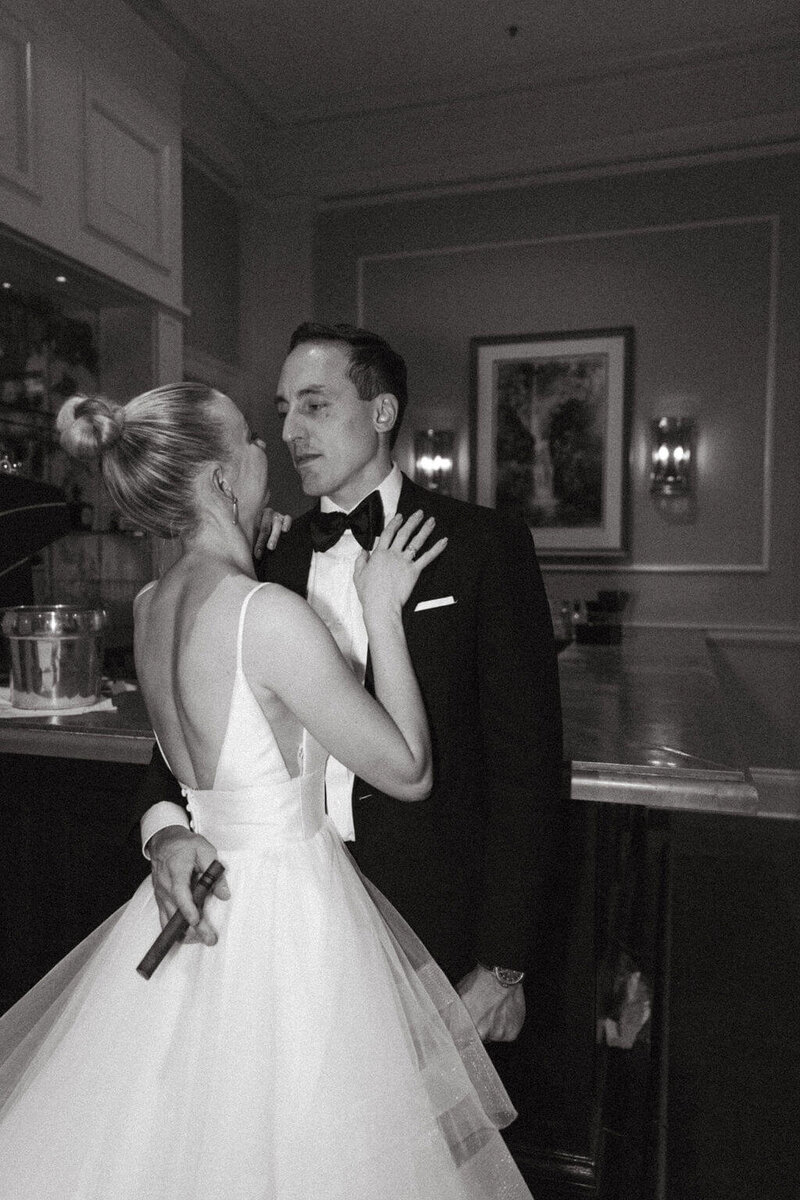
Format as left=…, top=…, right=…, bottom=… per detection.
left=353, top=509, right=447, bottom=618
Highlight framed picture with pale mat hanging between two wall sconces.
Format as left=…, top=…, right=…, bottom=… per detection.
left=470, top=326, right=633, bottom=559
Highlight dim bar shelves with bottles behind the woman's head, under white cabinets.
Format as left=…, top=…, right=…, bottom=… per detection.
left=0, top=230, right=164, bottom=644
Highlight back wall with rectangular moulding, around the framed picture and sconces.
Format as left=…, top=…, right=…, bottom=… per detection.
left=315, top=155, right=800, bottom=640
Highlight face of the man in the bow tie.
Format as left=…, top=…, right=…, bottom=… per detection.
left=276, top=342, right=379, bottom=508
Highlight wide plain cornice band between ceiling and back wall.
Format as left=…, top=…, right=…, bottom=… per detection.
left=266, top=46, right=800, bottom=202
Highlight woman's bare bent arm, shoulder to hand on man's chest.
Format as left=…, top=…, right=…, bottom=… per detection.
left=250, top=514, right=445, bottom=800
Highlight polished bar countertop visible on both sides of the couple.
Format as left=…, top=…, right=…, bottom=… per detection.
left=0, top=629, right=800, bottom=817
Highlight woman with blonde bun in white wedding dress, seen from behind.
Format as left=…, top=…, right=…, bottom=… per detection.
left=0, top=384, right=530, bottom=1200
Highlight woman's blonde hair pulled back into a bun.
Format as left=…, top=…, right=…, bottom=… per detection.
left=55, top=383, right=233, bottom=538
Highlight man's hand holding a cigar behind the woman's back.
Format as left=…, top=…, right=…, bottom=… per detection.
left=148, top=826, right=230, bottom=946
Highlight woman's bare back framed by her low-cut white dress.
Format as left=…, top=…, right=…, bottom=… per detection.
left=134, top=563, right=302, bottom=790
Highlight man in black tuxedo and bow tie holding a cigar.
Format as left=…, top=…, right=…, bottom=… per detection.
left=139, top=324, right=561, bottom=1040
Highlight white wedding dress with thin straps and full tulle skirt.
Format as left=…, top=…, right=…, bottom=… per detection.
left=0, top=584, right=530, bottom=1200
